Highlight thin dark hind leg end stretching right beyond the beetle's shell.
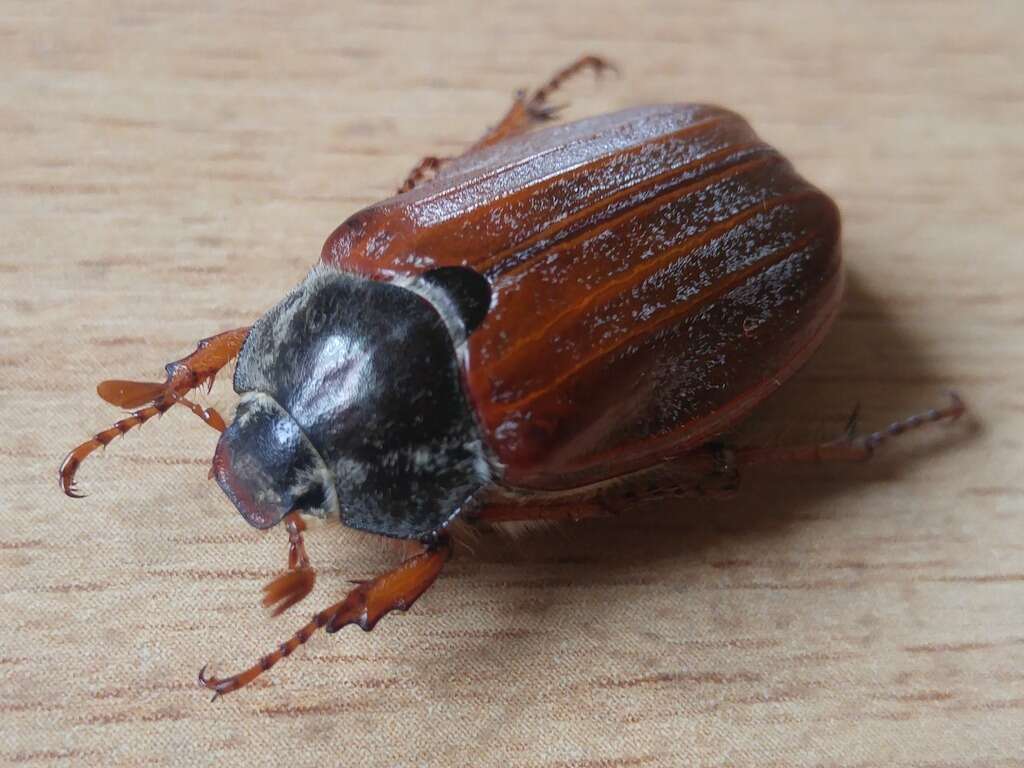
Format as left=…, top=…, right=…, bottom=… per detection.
left=735, top=392, right=967, bottom=467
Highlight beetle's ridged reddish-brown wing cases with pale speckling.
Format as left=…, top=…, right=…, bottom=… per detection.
left=322, top=104, right=842, bottom=488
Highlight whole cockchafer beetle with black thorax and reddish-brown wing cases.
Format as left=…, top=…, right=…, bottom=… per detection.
left=60, top=56, right=964, bottom=697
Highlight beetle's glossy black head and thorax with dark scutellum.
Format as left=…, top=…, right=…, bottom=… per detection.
left=214, top=266, right=493, bottom=539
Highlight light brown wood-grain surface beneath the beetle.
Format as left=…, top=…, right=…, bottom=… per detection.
left=0, top=0, right=1024, bottom=768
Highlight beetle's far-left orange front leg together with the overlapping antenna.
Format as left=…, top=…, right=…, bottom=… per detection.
left=59, top=328, right=249, bottom=498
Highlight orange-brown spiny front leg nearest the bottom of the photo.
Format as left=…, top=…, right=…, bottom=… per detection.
left=199, top=539, right=452, bottom=698
